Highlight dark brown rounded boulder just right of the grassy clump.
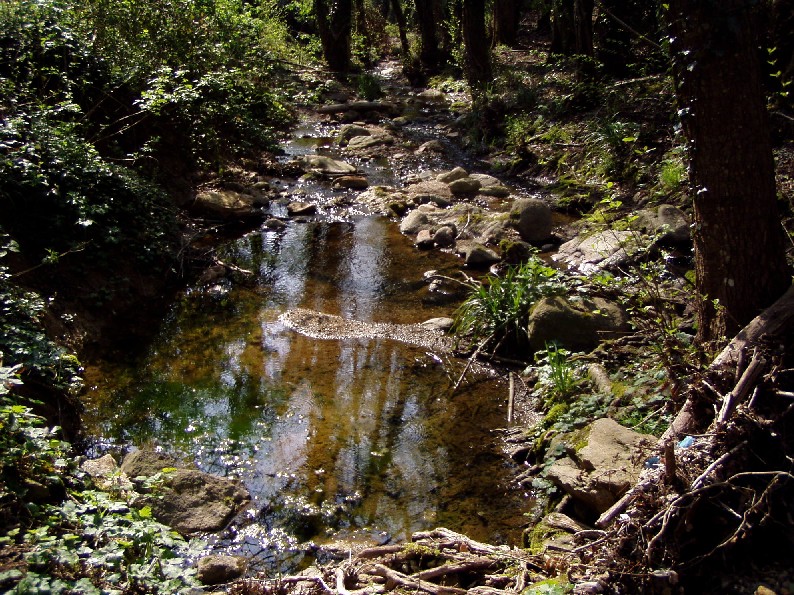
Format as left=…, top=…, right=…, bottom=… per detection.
left=527, top=296, right=628, bottom=351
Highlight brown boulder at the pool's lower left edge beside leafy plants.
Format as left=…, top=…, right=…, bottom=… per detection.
left=121, top=451, right=250, bottom=535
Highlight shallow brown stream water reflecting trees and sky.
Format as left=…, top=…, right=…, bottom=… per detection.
left=85, top=68, right=532, bottom=572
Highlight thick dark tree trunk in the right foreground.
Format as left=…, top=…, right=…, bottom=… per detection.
left=669, top=0, right=790, bottom=341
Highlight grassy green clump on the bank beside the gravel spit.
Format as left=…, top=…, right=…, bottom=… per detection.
left=454, top=256, right=567, bottom=351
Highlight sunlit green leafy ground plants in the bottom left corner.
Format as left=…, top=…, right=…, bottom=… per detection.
left=0, top=365, right=200, bottom=594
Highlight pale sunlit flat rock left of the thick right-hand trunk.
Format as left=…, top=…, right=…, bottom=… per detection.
left=553, top=230, right=637, bottom=274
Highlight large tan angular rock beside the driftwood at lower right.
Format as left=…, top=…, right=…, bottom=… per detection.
left=546, top=418, right=655, bottom=516
